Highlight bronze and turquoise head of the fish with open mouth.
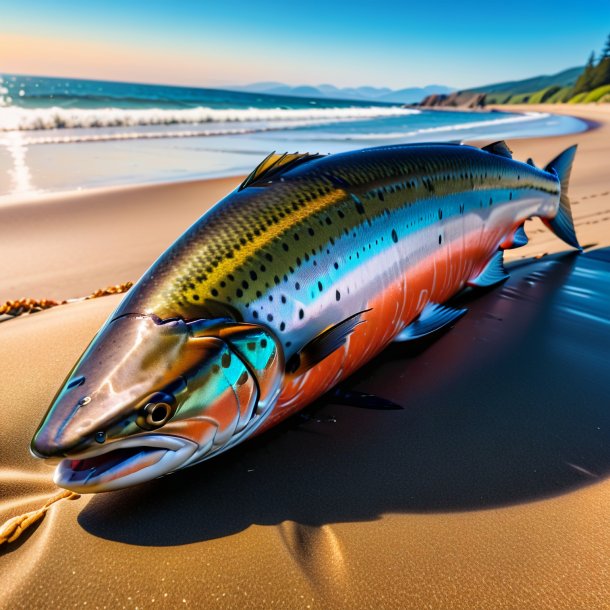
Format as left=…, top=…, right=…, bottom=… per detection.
left=31, top=314, right=284, bottom=493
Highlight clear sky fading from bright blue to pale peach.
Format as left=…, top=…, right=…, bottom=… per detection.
left=0, top=0, right=610, bottom=89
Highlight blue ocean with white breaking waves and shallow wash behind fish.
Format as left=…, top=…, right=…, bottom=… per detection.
left=0, top=75, right=586, bottom=201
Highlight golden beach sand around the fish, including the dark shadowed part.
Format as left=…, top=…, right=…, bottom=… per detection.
left=0, top=106, right=610, bottom=609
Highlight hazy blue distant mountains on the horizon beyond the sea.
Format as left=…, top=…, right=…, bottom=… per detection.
left=227, top=81, right=454, bottom=104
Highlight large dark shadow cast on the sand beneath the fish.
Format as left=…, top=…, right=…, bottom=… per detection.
left=78, top=248, right=610, bottom=546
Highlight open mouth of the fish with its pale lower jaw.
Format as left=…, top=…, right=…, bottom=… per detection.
left=53, top=434, right=197, bottom=493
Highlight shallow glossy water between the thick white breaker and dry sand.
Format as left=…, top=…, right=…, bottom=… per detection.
left=0, top=108, right=587, bottom=202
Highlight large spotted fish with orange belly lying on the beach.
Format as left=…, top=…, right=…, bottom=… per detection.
left=31, top=141, right=581, bottom=493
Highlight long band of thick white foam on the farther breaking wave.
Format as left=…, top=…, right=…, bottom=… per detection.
left=0, top=106, right=419, bottom=131
